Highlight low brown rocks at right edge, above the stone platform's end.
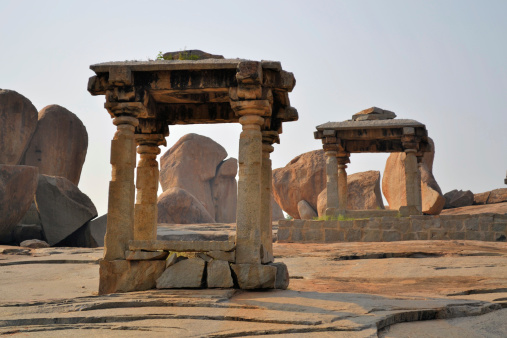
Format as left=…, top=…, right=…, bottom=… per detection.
left=444, top=188, right=507, bottom=209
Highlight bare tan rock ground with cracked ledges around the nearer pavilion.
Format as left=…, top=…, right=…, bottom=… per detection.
left=0, top=241, right=507, bottom=337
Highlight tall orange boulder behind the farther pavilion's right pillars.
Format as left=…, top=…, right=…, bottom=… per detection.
left=382, top=139, right=445, bottom=215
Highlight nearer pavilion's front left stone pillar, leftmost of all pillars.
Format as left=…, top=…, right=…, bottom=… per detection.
left=104, top=112, right=139, bottom=261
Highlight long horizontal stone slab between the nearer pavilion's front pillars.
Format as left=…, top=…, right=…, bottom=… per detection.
left=129, top=240, right=236, bottom=252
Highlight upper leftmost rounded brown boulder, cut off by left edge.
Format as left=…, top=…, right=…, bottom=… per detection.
left=0, top=89, right=37, bottom=165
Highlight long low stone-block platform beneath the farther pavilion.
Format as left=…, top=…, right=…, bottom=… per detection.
left=278, top=213, right=507, bottom=243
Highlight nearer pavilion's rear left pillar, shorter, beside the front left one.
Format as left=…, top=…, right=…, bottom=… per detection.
left=134, top=134, right=165, bottom=240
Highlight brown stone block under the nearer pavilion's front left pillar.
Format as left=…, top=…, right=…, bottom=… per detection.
left=99, top=260, right=165, bottom=295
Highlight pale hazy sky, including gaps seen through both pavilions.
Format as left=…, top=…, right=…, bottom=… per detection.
left=0, top=0, right=507, bottom=215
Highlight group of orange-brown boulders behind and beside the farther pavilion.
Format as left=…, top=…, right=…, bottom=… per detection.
left=273, top=139, right=445, bottom=219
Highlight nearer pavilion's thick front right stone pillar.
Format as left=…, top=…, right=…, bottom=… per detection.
left=236, top=114, right=264, bottom=264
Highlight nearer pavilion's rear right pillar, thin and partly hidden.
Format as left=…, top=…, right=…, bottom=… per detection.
left=261, top=131, right=278, bottom=264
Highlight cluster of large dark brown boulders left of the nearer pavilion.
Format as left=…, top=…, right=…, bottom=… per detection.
left=0, top=90, right=105, bottom=246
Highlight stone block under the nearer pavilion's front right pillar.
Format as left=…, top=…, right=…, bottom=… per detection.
left=231, top=264, right=278, bottom=290
